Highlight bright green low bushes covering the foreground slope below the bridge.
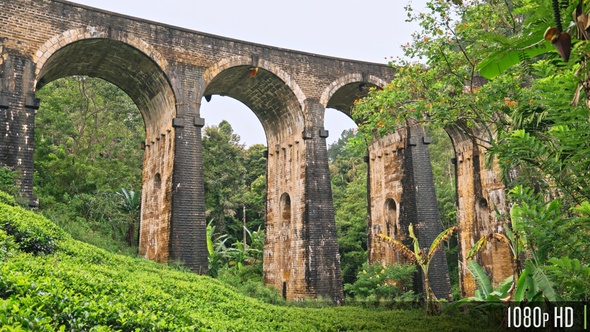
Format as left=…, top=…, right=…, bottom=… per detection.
left=0, top=194, right=494, bottom=331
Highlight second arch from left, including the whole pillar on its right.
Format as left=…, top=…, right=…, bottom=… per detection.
left=202, top=56, right=342, bottom=302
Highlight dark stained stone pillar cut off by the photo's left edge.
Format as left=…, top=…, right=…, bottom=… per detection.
left=0, top=49, right=39, bottom=207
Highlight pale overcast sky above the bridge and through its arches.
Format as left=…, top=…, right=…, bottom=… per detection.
left=68, top=0, right=426, bottom=145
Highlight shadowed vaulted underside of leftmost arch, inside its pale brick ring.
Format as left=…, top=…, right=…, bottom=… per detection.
left=36, top=38, right=176, bottom=140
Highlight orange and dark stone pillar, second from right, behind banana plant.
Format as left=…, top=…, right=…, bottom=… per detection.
left=367, top=126, right=451, bottom=299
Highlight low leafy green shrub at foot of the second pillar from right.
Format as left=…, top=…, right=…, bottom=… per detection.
left=344, top=262, right=416, bottom=302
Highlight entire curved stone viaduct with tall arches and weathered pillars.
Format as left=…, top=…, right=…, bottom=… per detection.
left=0, top=0, right=503, bottom=301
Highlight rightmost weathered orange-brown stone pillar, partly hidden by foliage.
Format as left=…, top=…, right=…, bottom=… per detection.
left=454, top=127, right=514, bottom=297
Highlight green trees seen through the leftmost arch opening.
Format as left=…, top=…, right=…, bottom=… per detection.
left=34, top=77, right=145, bottom=200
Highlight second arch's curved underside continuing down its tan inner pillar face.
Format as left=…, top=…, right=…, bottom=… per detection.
left=203, top=63, right=306, bottom=298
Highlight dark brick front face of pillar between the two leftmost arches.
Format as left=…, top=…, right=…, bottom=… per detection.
left=169, top=65, right=208, bottom=274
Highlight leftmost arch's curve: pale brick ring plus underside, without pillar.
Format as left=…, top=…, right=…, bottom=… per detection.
left=33, top=27, right=176, bottom=140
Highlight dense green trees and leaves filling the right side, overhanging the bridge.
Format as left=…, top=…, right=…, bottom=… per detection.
left=354, top=0, right=590, bottom=300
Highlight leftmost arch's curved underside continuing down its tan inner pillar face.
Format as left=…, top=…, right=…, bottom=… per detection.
left=35, top=36, right=176, bottom=262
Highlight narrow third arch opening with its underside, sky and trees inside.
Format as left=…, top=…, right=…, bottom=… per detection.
left=320, top=74, right=385, bottom=284
